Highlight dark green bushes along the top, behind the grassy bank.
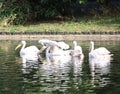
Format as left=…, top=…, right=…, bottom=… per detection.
left=0, top=0, right=120, bottom=26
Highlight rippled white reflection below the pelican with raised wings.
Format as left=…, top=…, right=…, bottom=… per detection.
left=40, top=56, right=71, bottom=91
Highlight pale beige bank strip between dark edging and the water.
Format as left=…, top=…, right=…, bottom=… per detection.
left=0, top=34, right=120, bottom=41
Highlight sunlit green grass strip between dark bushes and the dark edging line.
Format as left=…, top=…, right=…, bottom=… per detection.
left=0, top=15, right=120, bottom=32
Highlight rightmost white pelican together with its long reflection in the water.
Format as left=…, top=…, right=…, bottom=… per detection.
left=89, top=41, right=112, bottom=87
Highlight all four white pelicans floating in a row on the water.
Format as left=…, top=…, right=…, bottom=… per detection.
left=15, top=39, right=112, bottom=69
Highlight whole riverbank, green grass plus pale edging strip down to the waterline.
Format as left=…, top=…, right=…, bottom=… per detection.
left=0, top=15, right=120, bottom=41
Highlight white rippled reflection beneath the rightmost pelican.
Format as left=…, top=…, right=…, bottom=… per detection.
left=89, top=57, right=111, bottom=87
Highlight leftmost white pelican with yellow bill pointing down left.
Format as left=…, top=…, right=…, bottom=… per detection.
left=15, top=41, right=40, bottom=66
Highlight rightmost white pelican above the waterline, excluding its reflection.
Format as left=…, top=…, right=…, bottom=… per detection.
left=89, top=41, right=111, bottom=58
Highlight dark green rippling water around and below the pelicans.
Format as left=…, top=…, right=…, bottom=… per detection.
left=0, top=41, right=120, bottom=94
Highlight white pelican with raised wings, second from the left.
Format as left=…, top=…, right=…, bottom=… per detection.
left=39, top=39, right=71, bottom=61
